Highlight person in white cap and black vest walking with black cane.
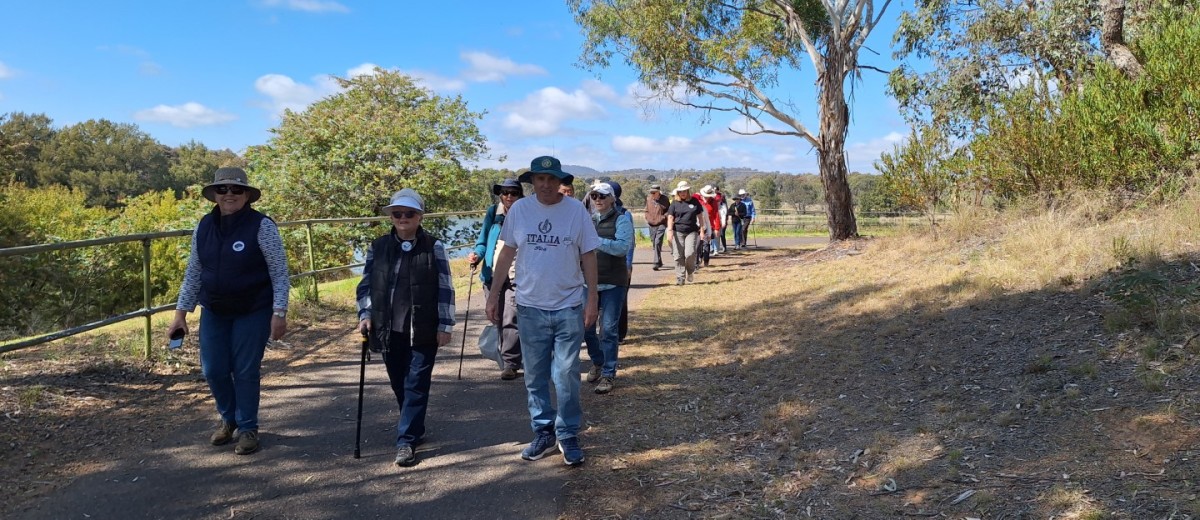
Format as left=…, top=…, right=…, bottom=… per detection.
left=356, top=189, right=455, bottom=466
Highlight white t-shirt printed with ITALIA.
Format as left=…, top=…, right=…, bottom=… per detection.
left=500, top=197, right=600, bottom=311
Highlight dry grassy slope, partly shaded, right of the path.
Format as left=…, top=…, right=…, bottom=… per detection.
left=564, top=190, right=1200, bottom=519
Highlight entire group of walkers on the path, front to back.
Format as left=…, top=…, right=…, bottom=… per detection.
left=168, top=156, right=754, bottom=466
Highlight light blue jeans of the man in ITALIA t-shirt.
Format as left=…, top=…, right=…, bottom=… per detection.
left=517, top=305, right=583, bottom=440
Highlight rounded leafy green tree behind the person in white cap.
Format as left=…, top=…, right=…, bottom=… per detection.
left=246, top=68, right=493, bottom=283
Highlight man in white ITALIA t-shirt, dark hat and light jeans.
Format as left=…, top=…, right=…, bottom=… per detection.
left=487, top=156, right=600, bottom=466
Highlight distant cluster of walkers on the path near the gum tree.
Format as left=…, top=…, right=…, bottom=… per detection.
left=646, top=180, right=756, bottom=285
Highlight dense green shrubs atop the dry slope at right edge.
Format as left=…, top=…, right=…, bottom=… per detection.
left=878, top=10, right=1200, bottom=208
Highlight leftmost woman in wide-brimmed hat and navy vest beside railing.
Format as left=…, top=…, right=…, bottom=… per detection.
left=167, top=168, right=292, bottom=455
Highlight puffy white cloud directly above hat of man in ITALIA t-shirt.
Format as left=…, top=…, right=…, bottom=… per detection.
left=502, top=86, right=605, bottom=136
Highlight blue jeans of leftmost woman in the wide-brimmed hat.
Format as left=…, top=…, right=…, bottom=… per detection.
left=200, top=306, right=272, bottom=431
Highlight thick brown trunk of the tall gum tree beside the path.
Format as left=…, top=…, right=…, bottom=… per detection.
left=817, top=49, right=858, bottom=240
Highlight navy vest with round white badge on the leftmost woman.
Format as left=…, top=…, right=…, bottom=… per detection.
left=196, top=205, right=274, bottom=315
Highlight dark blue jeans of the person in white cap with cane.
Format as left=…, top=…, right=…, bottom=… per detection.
left=383, top=330, right=438, bottom=448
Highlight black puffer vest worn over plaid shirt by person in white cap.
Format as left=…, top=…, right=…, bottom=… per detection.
left=371, top=228, right=439, bottom=349
